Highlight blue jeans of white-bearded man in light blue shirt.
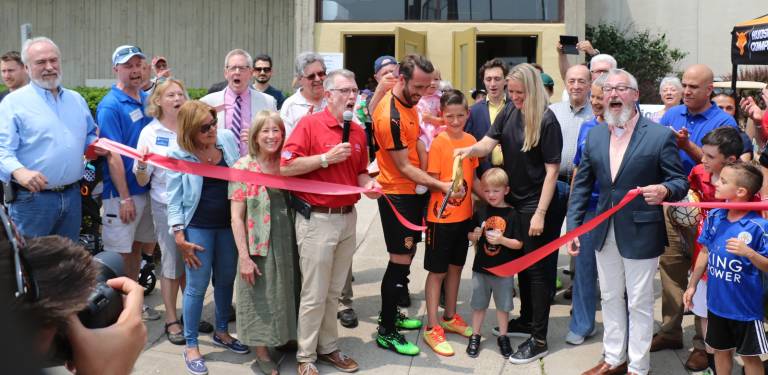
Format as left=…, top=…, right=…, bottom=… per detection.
left=8, top=187, right=83, bottom=242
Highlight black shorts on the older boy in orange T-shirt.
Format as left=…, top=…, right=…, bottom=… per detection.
left=424, top=220, right=471, bottom=273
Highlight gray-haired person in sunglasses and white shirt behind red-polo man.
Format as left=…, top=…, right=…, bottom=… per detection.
left=280, top=52, right=326, bottom=138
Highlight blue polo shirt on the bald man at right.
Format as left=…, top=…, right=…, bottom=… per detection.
left=659, top=102, right=739, bottom=175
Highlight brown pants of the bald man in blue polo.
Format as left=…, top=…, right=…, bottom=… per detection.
left=659, top=207, right=704, bottom=349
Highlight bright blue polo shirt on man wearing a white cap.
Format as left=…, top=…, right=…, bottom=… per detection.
left=96, top=85, right=152, bottom=199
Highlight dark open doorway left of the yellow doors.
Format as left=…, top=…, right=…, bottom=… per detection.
left=344, top=35, right=395, bottom=91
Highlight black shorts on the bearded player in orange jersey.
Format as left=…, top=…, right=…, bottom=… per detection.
left=378, top=194, right=429, bottom=254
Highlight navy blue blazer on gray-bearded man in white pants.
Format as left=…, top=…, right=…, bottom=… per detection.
left=567, top=116, right=688, bottom=259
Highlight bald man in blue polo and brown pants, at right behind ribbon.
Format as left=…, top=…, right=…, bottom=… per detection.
left=651, top=64, right=738, bottom=371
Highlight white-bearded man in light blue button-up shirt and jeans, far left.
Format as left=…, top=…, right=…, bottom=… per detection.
left=0, top=37, right=96, bottom=241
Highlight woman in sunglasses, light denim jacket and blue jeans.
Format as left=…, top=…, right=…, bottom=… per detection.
left=168, top=100, right=250, bottom=375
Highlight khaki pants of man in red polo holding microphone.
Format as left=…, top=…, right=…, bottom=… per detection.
left=296, top=210, right=357, bottom=362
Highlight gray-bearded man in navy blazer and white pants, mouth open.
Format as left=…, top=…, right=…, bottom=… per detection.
left=568, top=69, right=688, bottom=375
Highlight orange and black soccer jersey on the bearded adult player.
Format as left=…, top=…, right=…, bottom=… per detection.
left=373, top=90, right=419, bottom=194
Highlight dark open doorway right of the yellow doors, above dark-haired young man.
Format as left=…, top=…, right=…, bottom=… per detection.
left=476, top=35, right=538, bottom=87
